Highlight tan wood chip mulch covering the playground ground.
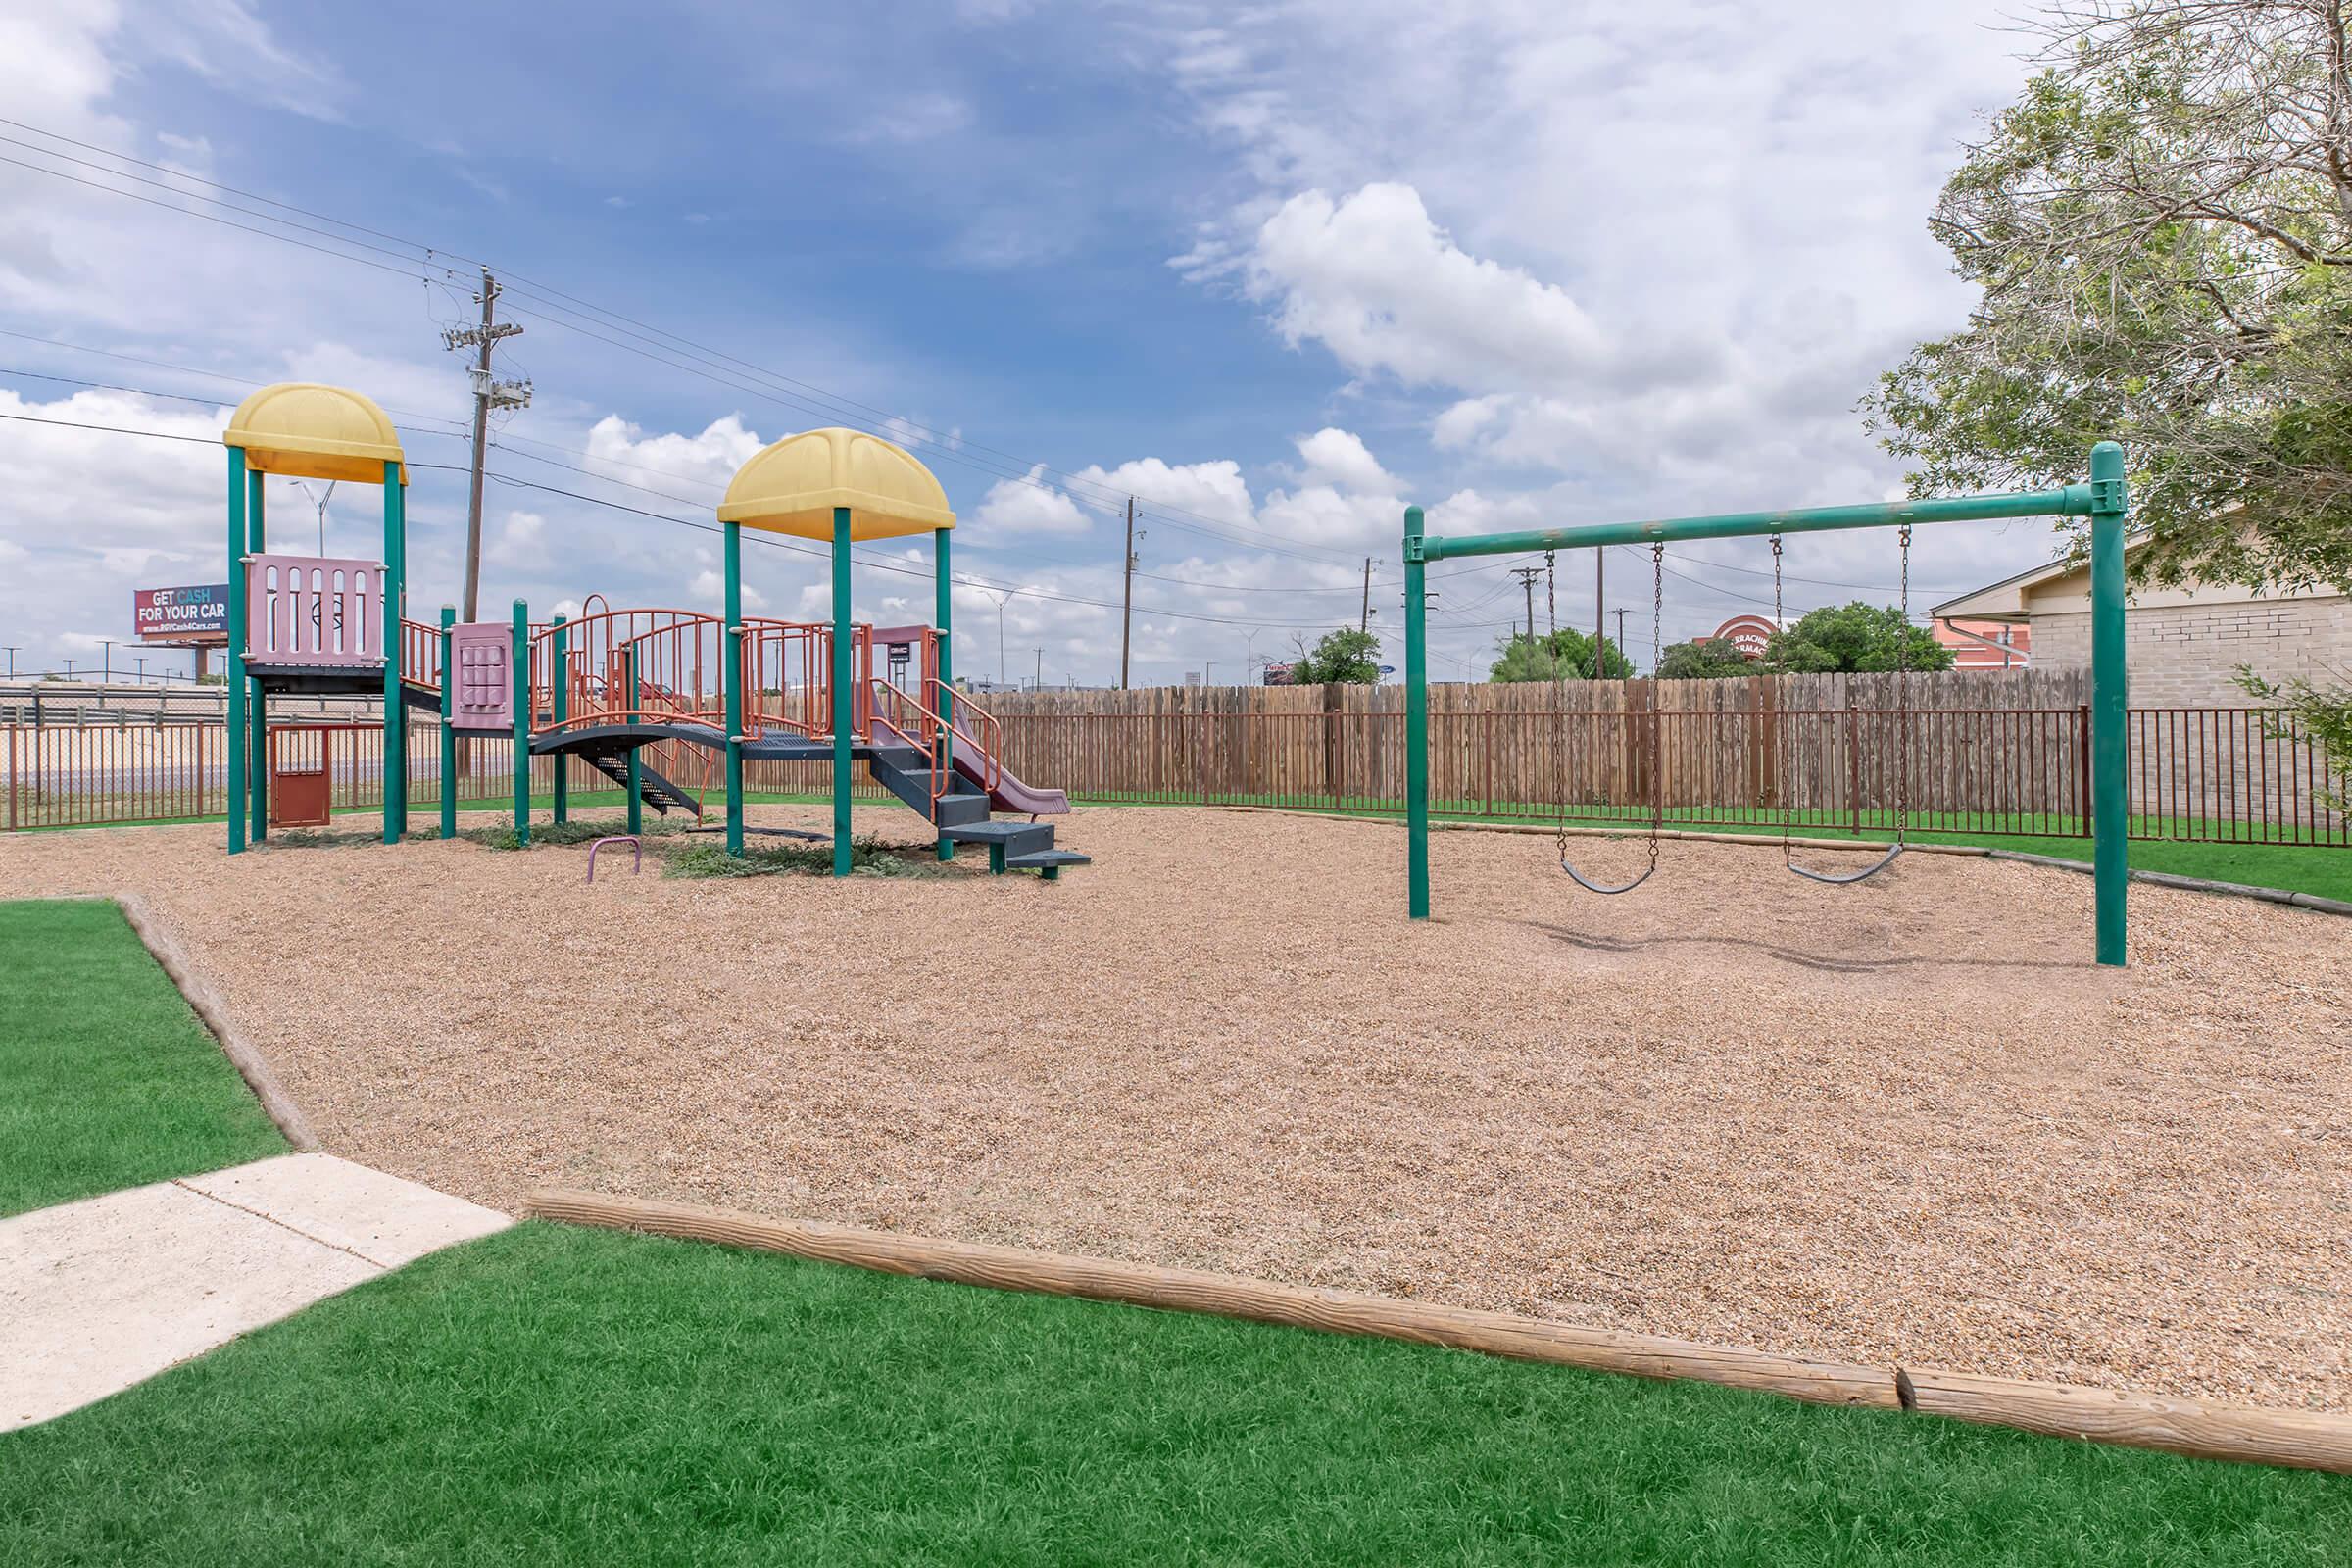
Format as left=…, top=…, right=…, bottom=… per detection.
left=0, top=807, right=2352, bottom=1410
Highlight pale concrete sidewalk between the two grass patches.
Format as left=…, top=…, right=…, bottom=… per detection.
left=0, top=1154, right=513, bottom=1432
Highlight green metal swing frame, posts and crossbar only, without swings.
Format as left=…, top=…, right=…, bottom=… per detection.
left=1404, top=442, right=2131, bottom=966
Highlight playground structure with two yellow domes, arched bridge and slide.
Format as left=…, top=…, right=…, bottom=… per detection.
left=223, top=383, right=1087, bottom=879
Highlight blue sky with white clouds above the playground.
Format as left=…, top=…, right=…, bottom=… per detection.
left=0, top=0, right=2051, bottom=682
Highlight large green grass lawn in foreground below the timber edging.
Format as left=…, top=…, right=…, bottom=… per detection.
left=0, top=1225, right=2352, bottom=1568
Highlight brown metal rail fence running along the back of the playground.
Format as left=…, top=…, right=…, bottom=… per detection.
left=5, top=682, right=2352, bottom=844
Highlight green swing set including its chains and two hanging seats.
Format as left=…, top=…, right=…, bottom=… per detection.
left=1404, top=442, right=2129, bottom=966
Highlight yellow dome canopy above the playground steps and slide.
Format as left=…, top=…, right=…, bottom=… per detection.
left=719, top=425, right=955, bottom=541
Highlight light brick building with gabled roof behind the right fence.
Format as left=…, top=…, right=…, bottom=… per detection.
left=1929, top=545, right=2352, bottom=708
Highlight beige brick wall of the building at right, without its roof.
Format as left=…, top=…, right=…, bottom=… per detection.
left=2034, top=595, right=2352, bottom=708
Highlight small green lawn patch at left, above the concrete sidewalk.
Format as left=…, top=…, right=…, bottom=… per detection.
left=0, top=898, right=287, bottom=1213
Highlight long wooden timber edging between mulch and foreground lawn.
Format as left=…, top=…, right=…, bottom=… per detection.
left=524, top=1190, right=2352, bottom=1474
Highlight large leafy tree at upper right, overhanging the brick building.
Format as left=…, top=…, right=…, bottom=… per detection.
left=1863, top=0, right=2352, bottom=590
